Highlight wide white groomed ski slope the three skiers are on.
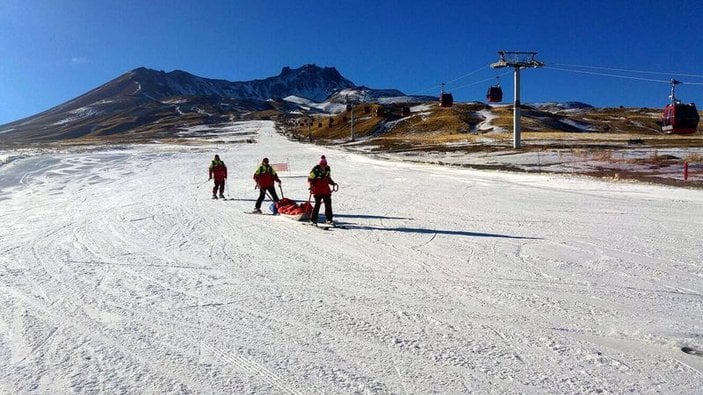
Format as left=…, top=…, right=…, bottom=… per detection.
left=0, top=122, right=703, bottom=394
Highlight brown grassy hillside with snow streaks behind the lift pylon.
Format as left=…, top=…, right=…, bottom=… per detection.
left=287, top=103, right=703, bottom=151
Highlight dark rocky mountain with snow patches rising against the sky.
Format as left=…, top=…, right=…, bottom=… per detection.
left=0, top=64, right=418, bottom=144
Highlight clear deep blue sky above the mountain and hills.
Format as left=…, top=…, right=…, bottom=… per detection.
left=0, top=0, right=703, bottom=124
